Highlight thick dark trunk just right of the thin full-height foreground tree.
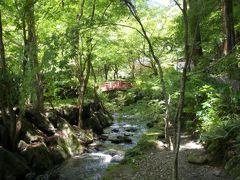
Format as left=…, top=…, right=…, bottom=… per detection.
left=189, top=0, right=203, bottom=66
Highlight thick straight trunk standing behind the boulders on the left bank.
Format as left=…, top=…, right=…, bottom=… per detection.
left=26, top=0, right=44, bottom=112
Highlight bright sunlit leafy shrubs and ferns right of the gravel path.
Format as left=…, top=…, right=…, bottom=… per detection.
left=196, top=79, right=240, bottom=168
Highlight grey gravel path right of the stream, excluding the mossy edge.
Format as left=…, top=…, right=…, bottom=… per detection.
left=106, top=136, right=233, bottom=180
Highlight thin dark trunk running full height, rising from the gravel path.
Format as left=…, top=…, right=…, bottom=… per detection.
left=172, top=0, right=190, bottom=180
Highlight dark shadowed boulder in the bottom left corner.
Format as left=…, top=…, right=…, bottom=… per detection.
left=0, top=147, right=30, bottom=180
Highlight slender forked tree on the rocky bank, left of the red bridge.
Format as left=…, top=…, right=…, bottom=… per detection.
left=73, top=0, right=96, bottom=128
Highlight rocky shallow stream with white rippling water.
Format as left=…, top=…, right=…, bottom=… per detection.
left=39, top=113, right=146, bottom=180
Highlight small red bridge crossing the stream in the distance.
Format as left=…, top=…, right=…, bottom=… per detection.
left=100, top=80, right=133, bottom=92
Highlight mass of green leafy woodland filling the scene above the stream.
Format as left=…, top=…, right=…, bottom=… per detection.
left=0, top=0, right=240, bottom=178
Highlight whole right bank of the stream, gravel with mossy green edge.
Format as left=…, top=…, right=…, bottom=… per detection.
left=103, top=129, right=233, bottom=180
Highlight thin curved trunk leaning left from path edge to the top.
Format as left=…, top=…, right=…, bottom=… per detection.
left=124, top=0, right=173, bottom=149
